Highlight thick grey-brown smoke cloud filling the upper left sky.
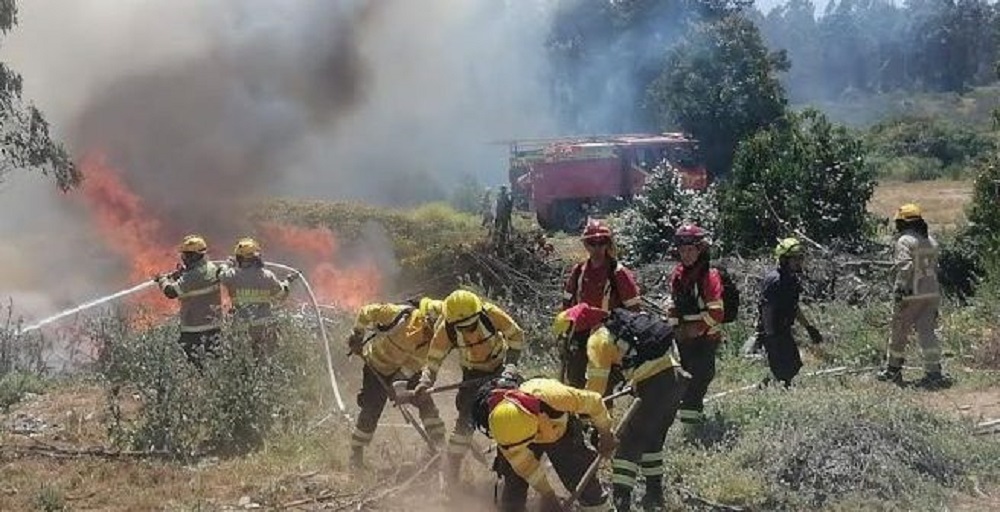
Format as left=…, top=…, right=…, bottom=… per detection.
left=0, top=0, right=554, bottom=320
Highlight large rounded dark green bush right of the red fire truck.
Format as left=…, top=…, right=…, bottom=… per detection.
left=718, top=110, right=875, bottom=254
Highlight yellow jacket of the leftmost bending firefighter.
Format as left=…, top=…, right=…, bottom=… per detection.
left=354, top=304, right=430, bottom=377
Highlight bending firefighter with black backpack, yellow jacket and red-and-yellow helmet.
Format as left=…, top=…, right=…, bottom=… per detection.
left=553, top=304, right=690, bottom=510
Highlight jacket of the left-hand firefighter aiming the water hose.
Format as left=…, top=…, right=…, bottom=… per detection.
left=160, top=259, right=222, bottom=332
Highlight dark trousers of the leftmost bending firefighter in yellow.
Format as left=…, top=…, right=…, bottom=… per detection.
left=351, top=365, right=444, bottom=449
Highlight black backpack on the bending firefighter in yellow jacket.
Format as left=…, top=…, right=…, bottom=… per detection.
left=604, top=308, right=674, bottom=368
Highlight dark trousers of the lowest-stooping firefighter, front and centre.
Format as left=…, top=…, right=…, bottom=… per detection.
left=494, top=418, right=608, bottom=512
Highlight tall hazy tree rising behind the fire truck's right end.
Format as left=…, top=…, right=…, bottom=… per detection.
left=647, top=14, right=789, bottom=175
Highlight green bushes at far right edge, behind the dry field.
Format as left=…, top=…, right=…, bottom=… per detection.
left=865, top=117, right=997, bottom=181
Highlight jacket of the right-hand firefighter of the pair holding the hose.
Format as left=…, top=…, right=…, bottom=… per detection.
left=219, top=266, right=288, bottom=325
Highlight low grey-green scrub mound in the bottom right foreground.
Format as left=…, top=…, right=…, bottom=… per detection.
left=667, top=381, right=1000, bottom=510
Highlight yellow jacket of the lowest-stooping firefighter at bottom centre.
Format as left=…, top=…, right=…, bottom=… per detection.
left=500, top=379, right=611, bottom=494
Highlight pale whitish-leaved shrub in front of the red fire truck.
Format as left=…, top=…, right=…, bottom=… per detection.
left=613, top=164, right=717, bottom=265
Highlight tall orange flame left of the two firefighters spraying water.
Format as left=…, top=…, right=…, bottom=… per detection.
left=80, top=151, right=176, bottom=315
